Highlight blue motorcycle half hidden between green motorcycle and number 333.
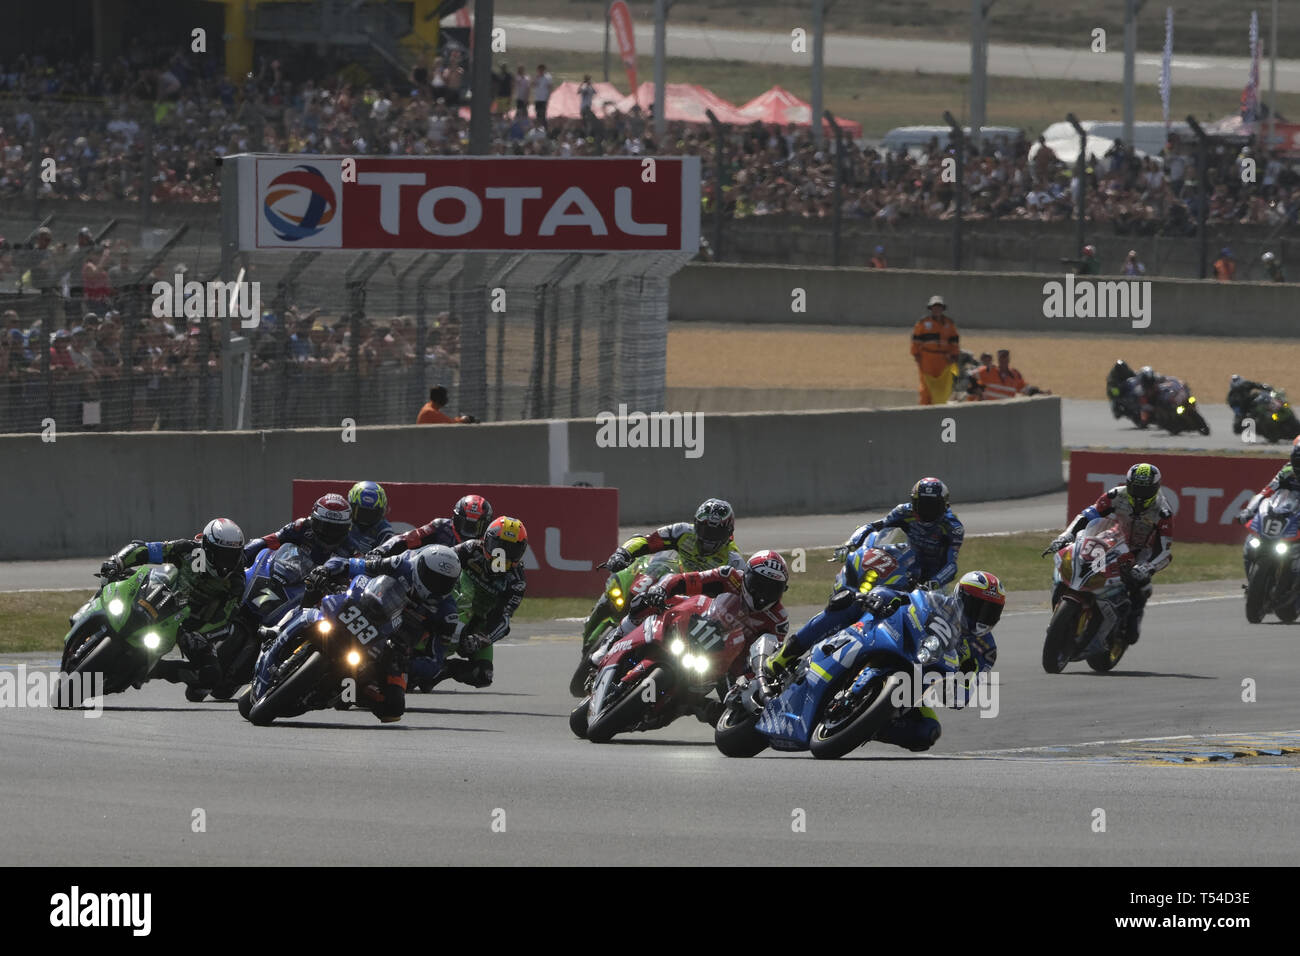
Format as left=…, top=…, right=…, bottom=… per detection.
left=197, top=545, right=312, bottom=700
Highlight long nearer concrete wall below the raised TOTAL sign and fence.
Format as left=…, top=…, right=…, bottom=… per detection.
left=0, top=397, right=1062, bottom=561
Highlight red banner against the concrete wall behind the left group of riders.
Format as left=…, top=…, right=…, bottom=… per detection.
left=294, top=479, right=619, bottom=600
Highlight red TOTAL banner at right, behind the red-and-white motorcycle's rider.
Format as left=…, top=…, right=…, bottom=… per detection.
left=1066, top=451, right=1286, bottom=546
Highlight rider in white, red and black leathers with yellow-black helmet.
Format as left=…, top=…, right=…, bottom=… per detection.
left=1043, top=462, right=1174, bottom=645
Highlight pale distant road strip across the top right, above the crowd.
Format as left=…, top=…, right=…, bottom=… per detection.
left=493, top=12, right=1300, bottom=92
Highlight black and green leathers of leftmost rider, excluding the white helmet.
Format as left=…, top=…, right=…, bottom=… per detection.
left=103, top=538, right=244, bottom=687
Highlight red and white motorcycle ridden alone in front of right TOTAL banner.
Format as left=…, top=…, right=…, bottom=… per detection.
left=1043, top=515, right=1132, bottom=674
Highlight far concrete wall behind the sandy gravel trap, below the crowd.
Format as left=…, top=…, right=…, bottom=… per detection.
left=668, top=263, right=1300, bottom=339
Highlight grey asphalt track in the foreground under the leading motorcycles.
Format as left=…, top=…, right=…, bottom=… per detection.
left=0, top=588, right=1300, bottom=866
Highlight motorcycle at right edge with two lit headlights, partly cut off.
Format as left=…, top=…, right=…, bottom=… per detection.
left=1242, top=488, right=1300, bottom=624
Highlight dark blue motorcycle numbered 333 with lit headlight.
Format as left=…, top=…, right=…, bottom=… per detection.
left=239, top=575, right=407, bottom=726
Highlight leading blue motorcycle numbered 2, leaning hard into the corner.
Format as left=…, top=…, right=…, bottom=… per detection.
left=714, top=591, right=965, bottom=760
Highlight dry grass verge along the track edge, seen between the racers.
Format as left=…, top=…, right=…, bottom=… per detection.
left=0, top=532, right=1242, bottom=653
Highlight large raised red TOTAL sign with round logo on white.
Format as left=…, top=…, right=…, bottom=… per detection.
left=237, top=153, right=699, bottom=252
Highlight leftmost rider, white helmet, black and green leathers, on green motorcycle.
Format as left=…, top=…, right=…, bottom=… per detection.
left=100, top=518, right=244, bottom=696
